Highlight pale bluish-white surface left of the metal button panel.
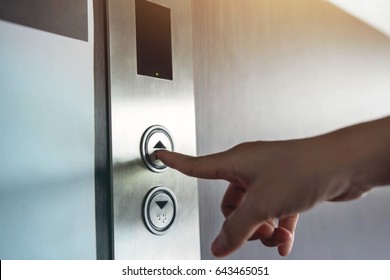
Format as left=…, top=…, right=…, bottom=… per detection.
left=0, top=0, right=96, bottom=259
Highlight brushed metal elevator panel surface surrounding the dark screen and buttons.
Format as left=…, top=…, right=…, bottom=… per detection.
left=108, top=0, right=200, bottom=259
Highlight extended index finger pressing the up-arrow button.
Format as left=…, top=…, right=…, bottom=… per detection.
left=156, top=150, right=228, bottom=179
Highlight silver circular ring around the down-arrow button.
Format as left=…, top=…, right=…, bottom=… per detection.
left=143, top=187, right=178, bottom=235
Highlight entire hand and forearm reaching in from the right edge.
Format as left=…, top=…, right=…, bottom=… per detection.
left=156, top=117, right=390, bottom=257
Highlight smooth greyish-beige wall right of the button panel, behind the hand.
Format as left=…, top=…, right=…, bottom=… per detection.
left=193, top=0, right=390, bottom=259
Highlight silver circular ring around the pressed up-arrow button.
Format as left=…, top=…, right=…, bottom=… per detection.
left=140, top=125, right=174, bottom=173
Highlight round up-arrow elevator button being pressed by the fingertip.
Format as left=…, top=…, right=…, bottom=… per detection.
left=141, top=125, right=174, bottom=172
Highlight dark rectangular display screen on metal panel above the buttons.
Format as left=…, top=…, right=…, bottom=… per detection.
left=135, top=0, right=173, bottom=80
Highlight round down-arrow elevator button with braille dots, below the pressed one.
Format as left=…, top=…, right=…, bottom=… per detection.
left=143, top=187, right=177, bottom=235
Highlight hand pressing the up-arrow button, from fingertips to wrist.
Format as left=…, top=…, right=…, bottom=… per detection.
left=157, top=135, right=370, bottom=257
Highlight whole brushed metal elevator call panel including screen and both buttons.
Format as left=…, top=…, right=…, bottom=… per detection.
left=108, top=0, right=200, bottom=259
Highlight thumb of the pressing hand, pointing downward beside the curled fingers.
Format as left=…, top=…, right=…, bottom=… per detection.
left=211, top=196, right=266, bottom=257
